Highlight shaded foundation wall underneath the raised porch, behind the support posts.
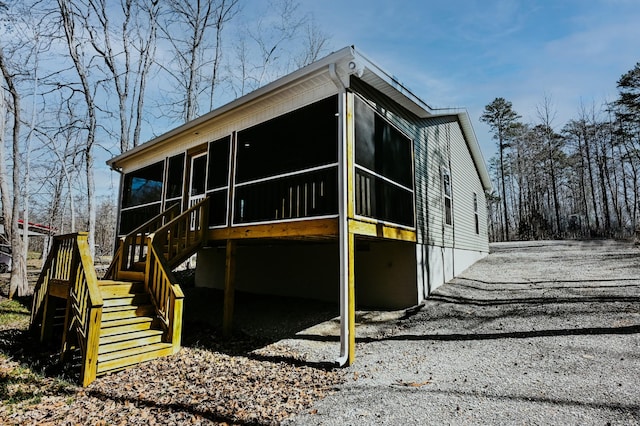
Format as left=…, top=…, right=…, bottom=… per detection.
left=195, top=242, right=418, bottom=309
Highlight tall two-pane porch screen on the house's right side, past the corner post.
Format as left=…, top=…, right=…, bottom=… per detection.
left=354, top=97, right=415, bottom=227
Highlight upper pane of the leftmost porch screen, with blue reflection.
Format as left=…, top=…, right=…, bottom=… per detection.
left=122, top=161, right=164, bottom=208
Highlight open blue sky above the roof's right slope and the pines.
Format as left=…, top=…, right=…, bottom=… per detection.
left=301, top=0, right=640, bottom=161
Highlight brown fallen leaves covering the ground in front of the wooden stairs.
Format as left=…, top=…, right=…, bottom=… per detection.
left=0, top=342, right=341, bottom=425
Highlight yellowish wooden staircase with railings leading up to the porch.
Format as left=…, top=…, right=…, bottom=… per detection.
left=31, top=199, right=208, bottom=386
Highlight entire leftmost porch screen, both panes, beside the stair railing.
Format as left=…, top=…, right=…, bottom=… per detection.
left=120, top=161, right=164, bottom=235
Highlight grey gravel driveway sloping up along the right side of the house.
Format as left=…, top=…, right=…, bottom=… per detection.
left=284, top=240, right=640, bottom=425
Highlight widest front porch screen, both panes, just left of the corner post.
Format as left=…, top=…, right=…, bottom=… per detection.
left=233, top=96, right=338, bottom=224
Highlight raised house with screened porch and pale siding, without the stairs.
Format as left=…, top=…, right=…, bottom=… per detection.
left=108, top=47, right=491, bottom=364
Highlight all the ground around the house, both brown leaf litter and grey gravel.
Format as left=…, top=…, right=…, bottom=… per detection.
left=0, top=241, right=640, bottom=426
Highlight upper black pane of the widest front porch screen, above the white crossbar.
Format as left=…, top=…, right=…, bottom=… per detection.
left=236, top=96, right=338, bottom=183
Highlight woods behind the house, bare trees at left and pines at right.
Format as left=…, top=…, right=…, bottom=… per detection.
left=0, top=0, right=640, bottom=293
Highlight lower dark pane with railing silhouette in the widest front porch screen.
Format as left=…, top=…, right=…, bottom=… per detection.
left=234, top=167, right=338, bottom=223
